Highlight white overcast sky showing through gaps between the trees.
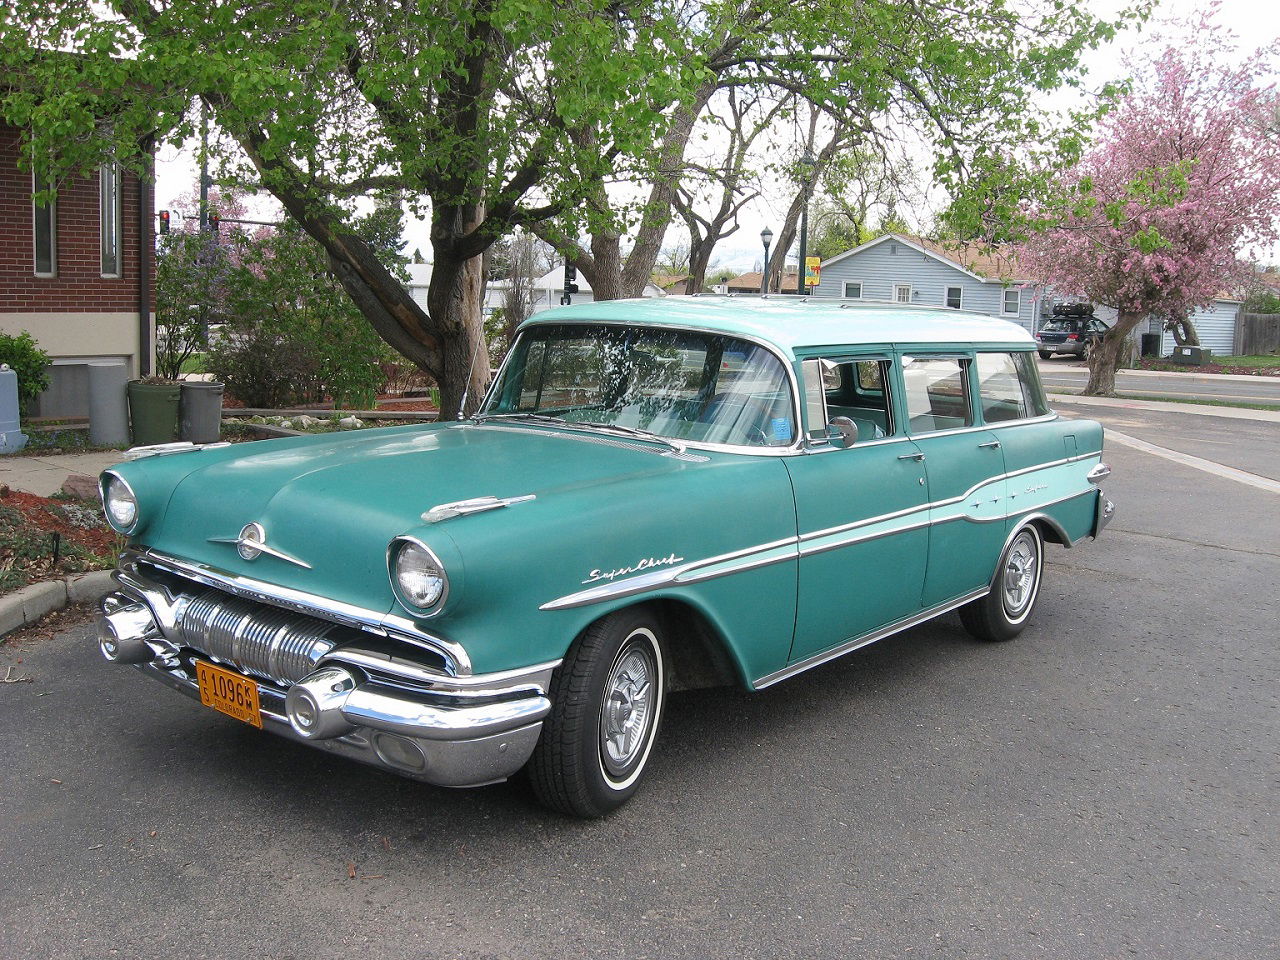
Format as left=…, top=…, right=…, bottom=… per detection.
left=156, top=0, right=1280, bottom=271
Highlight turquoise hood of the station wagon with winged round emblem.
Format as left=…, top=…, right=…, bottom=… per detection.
left=128, top=424, right=701, bottom=609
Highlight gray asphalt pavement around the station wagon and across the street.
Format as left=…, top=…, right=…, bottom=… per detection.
left=0, top=408, right=1280, bottom=960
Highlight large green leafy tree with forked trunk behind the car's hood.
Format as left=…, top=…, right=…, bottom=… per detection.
left=0, top=0, right=695, bottom=419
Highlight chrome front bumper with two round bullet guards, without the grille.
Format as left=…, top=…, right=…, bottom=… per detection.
left=99, top=575, right=558, bottom=787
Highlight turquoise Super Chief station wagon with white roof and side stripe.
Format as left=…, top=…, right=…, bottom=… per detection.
left=99, top=297, right=1114, bottom=817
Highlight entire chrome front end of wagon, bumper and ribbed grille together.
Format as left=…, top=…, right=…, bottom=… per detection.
left=99, top=550, right=558, bottom=787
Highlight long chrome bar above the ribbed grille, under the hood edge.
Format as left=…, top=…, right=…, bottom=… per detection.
left=129, top=549, right=471, bottom=676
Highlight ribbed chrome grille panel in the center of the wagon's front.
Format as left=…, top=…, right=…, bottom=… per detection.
left=177, top=590, right=347, bottom=686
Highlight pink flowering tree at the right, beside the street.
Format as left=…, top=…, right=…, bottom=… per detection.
left=1019, top=18, right=1280, bottom=396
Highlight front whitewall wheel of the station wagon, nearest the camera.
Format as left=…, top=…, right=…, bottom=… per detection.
left=527, top=608, right=667, bottom=817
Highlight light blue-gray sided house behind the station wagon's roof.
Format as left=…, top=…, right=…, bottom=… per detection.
left=814, top=233, right=1043, bottom=333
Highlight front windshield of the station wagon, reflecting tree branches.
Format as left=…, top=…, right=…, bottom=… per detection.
left=479, top=324, right=795, bottom=447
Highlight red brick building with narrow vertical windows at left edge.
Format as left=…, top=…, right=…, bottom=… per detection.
left=0, top=123, right=155, bottom=416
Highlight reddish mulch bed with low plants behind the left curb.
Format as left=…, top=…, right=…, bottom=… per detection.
left=0, top=485, right=119, bottom=593
